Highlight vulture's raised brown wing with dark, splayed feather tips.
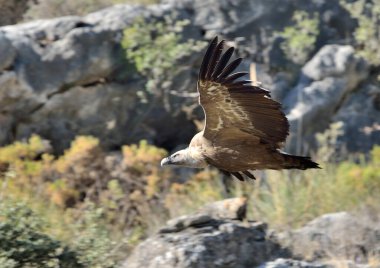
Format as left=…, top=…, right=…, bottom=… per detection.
left=198, top=37, right=289, bottom=148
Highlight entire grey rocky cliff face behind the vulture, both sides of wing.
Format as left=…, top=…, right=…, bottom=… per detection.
left=0, top=0, right=380, bottom=155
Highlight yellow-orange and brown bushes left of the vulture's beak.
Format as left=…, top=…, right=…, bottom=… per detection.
left=0, top=136, right=172, bottom=242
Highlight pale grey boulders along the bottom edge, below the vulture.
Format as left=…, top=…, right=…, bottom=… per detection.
left=123, top=198, right=380, bottom=268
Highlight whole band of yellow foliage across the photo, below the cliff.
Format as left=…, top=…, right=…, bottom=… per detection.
left=0, top=132, right=380, bottom=251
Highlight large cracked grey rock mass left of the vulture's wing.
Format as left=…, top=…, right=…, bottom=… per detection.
left=0, top=5, right=200, bottom=153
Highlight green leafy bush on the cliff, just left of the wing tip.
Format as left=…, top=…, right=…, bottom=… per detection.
left=122, top=16, right=204, bottom=104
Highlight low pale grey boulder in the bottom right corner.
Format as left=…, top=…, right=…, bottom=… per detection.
left=278, top=212, right=380, bottom=263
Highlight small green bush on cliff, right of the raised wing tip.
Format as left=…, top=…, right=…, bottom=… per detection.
left=279, top=11, right=319, bottom=65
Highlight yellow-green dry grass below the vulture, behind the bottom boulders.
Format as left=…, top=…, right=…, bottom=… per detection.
left=166, top=147, right=380, bottom=229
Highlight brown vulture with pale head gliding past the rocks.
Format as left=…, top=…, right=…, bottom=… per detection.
left=161, top=37, right=319, bottom=181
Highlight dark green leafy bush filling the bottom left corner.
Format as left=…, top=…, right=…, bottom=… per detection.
left=0, top=201, right=84, bottom=268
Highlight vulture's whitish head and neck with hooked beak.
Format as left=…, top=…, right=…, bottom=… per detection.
left=161, top=148, right=207, bottom=168
